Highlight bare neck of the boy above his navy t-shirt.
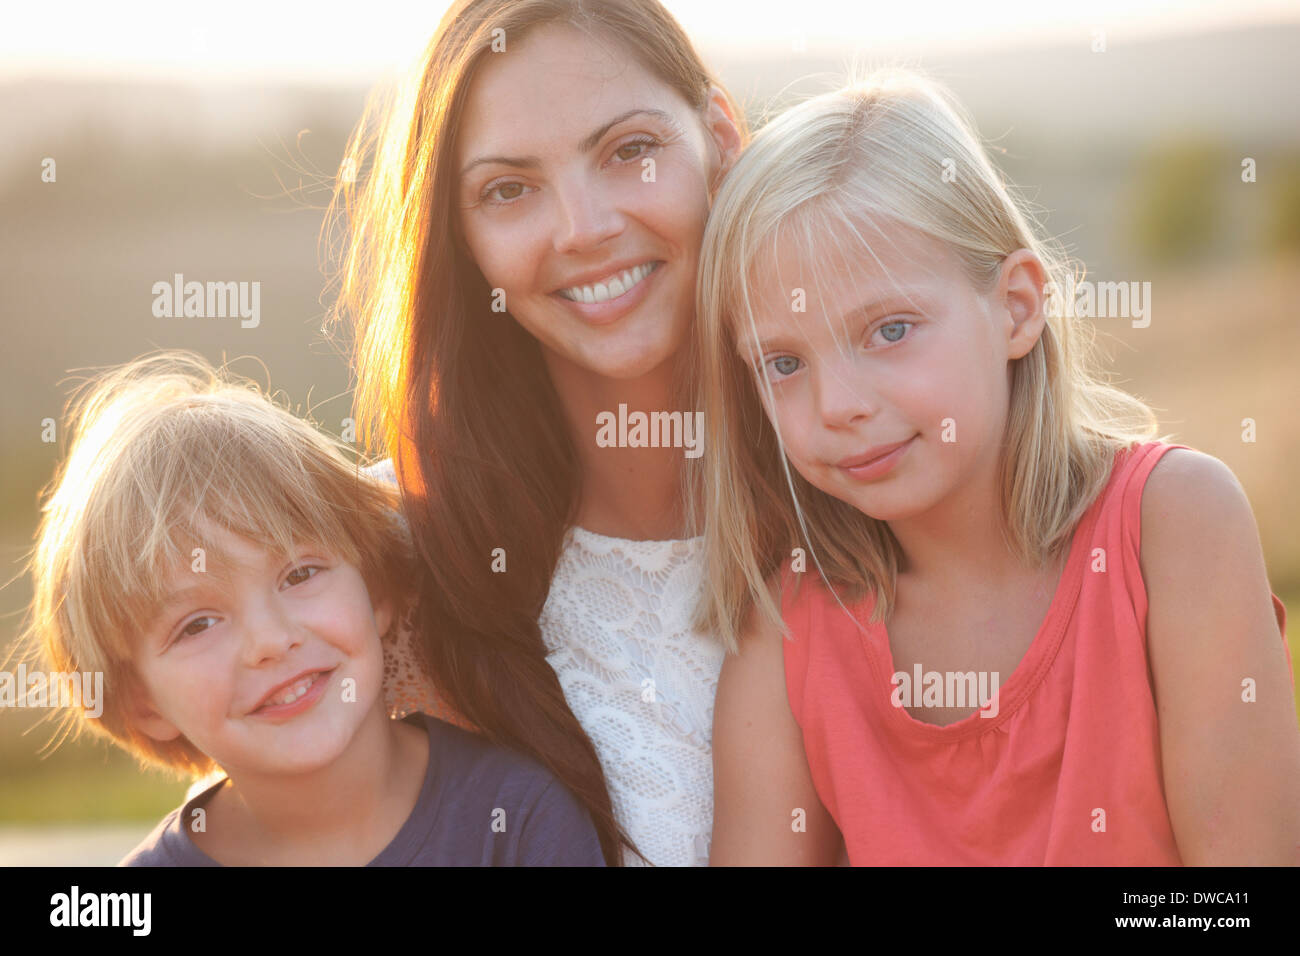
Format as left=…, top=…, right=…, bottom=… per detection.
left=208, top=701, right=429, bottom=865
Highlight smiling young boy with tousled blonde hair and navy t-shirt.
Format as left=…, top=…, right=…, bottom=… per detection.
left=26, top=352, right=603, bottom=866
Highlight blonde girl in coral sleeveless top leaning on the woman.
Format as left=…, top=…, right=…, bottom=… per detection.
left=692, top=74, right=1300, bottom=865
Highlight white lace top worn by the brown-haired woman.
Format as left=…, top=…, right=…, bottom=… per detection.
left=369, top=462, right=724, bottom=866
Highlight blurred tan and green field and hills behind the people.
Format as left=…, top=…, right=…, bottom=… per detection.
left=0, top=27, right=1300, bottom=864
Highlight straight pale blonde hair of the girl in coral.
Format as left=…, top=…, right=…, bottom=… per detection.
left=684, top=70, right=1156, bottom=649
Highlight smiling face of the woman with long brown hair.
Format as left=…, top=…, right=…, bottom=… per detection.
left=455, top=25, right=740, bottom=378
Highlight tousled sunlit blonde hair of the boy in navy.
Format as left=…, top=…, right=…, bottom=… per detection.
left=18, top=351, right=411, bottom=775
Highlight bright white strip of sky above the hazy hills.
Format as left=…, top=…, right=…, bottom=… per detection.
left=0, top=0, right=1300, bottom=83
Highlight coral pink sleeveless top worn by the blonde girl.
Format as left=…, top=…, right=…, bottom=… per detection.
left=783, top=442, right=1290, bottom=866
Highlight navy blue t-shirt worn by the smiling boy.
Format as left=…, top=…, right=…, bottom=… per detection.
left=118, top=714, right=605, bottom=866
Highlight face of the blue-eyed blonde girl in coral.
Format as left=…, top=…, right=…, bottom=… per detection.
left=737, top=219, right=1043, bottom=522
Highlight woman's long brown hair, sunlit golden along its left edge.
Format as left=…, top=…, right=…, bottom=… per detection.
left=329, top=0, right=746, bottom=865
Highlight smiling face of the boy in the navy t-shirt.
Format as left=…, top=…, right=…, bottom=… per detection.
left=134, top=529, right=390, bottom=774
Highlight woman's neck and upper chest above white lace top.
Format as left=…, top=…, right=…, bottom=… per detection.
left=549, top=348, right=686, bottom=541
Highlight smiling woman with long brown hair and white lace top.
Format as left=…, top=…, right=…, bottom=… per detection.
left=335, top=0, right=748, bottom=865
